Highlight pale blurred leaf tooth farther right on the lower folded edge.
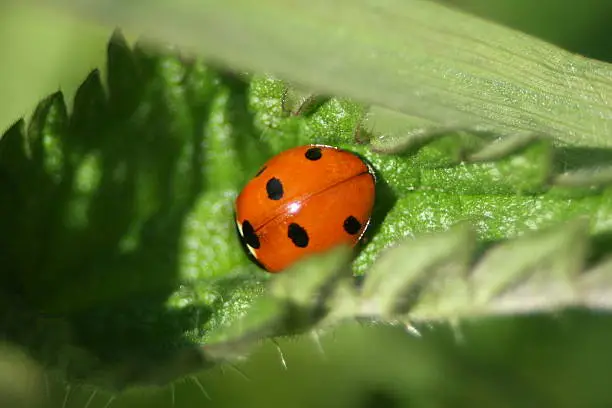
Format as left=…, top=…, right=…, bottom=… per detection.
left=470, top=220, right=587, bottom=313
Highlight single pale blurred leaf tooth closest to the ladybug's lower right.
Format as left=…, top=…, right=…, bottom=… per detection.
left=361, top=225, right=474, bottom=320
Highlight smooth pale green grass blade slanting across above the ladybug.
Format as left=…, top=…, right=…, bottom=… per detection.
left=37, top=0, right=612, bottom=147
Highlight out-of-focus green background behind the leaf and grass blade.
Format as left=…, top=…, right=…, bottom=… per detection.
left=0, top=0, right=612, bottom=408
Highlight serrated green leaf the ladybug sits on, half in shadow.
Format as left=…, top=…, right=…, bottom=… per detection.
left=0, top=34, right=612, bottom=402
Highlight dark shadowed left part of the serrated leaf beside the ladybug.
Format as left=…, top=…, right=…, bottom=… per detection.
left=0, top=35, right=222, bottom=386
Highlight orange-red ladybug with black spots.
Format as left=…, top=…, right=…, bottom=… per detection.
left=235, top=144, right=376, bottom=273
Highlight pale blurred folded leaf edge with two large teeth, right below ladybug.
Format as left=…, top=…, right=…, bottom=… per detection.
left=356, top=220, right=612, bottom=324
